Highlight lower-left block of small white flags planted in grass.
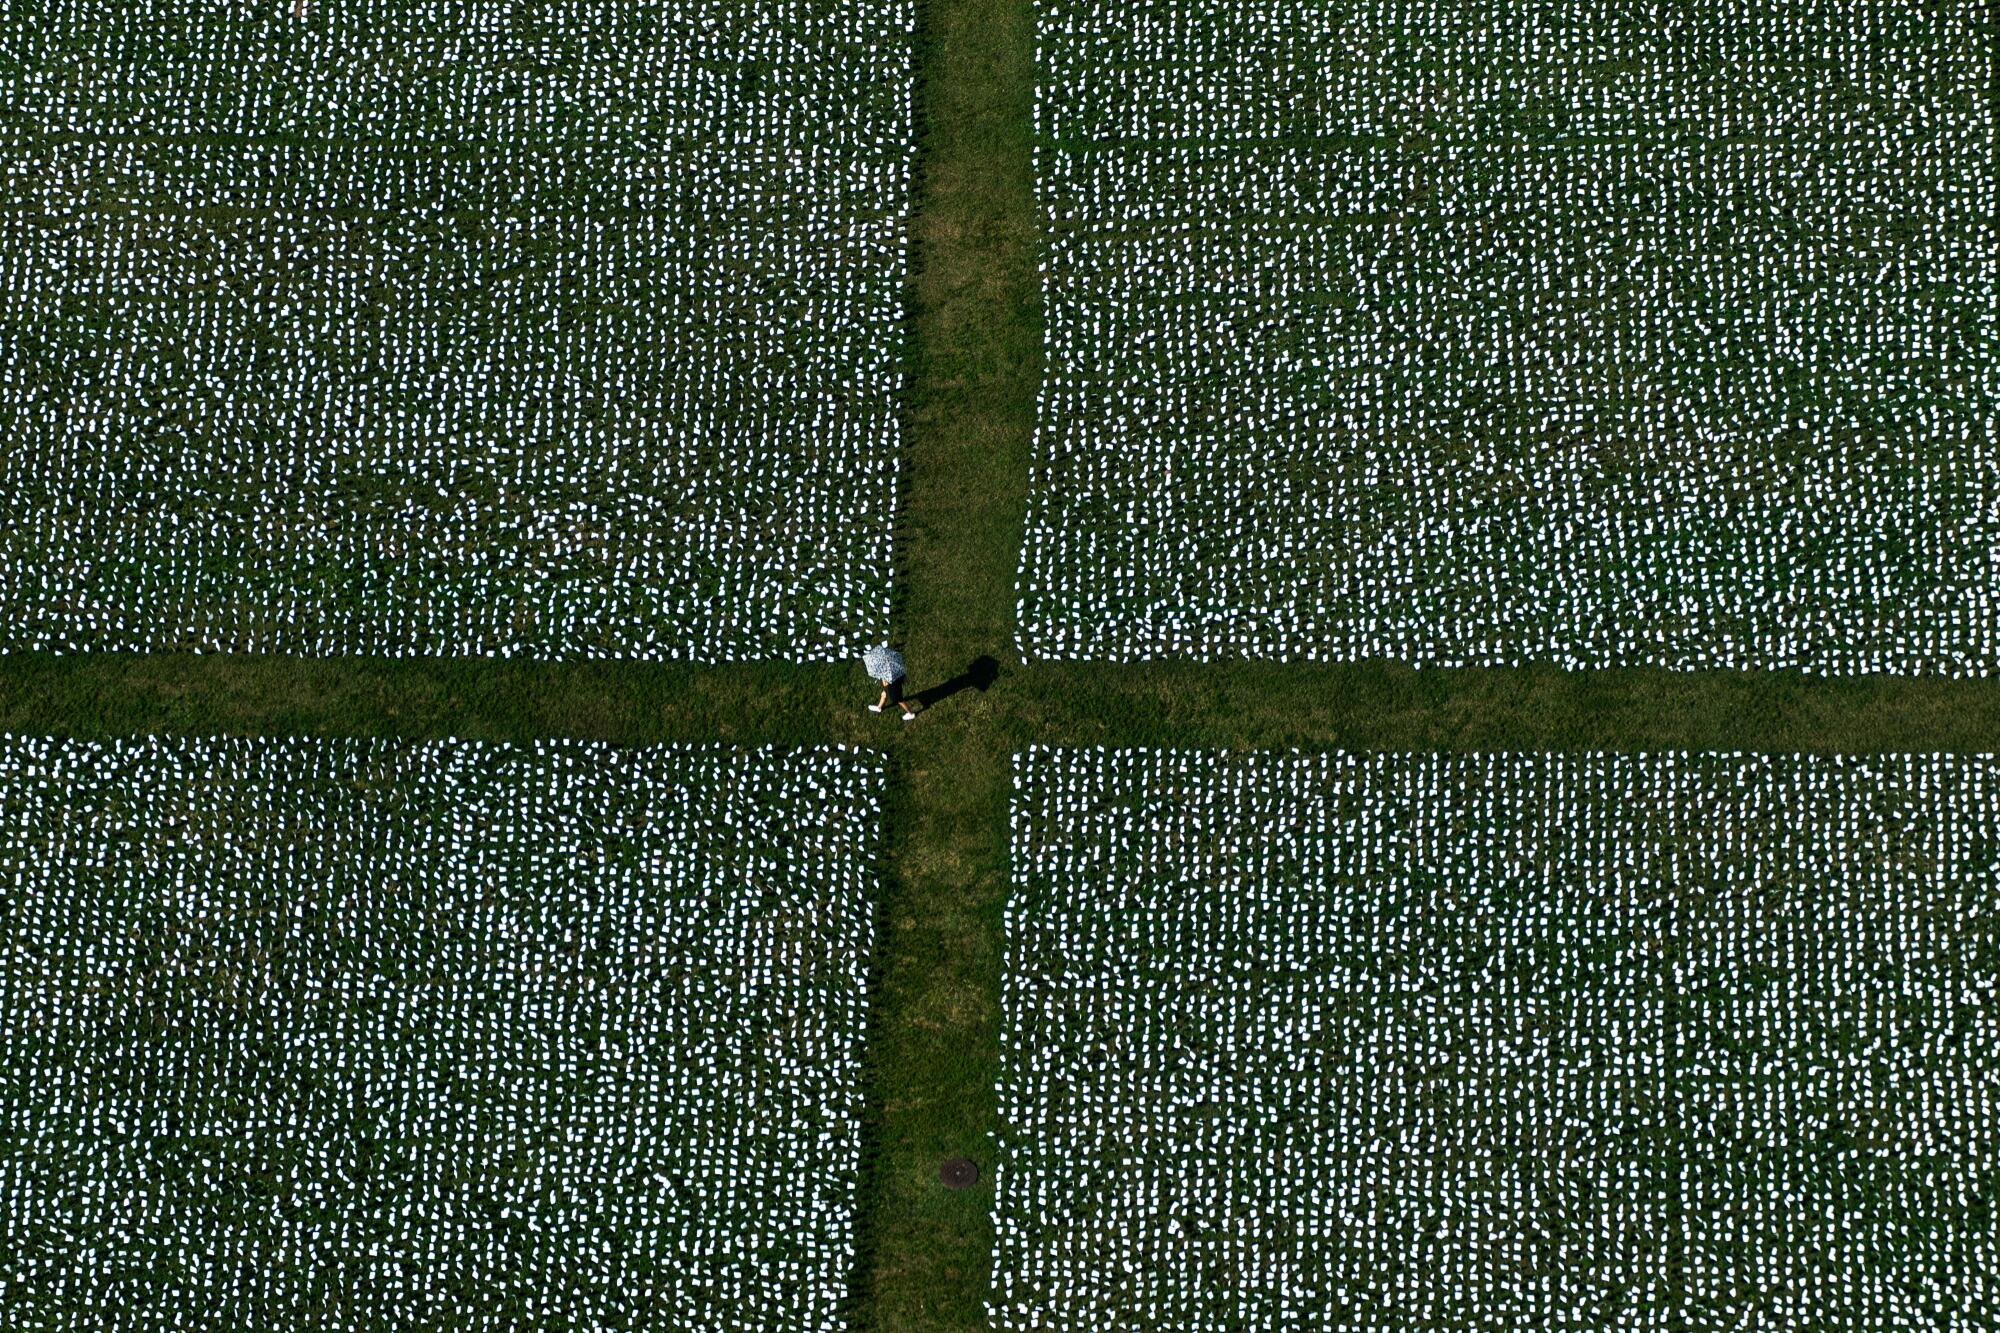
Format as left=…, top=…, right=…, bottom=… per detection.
left=0, top=737, right=884, bottom=1333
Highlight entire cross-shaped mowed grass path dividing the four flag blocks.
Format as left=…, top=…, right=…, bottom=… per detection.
left=0, top=0, right=2000, bottom=1329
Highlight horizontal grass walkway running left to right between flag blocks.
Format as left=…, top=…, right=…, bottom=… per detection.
left=0, top=656, right=2000, bottom=756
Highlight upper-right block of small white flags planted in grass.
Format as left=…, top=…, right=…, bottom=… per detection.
left=1018, top=0, right=2000, bottom=675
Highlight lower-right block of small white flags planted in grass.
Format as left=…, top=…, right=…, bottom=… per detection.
left=992, top=747, right=2000, bottom=1331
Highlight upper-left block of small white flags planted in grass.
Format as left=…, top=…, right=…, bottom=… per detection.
left=0, top=0, right=914, bottom=662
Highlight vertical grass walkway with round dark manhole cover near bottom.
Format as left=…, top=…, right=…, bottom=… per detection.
left=856, top=0, right=1042, bottom=1329
